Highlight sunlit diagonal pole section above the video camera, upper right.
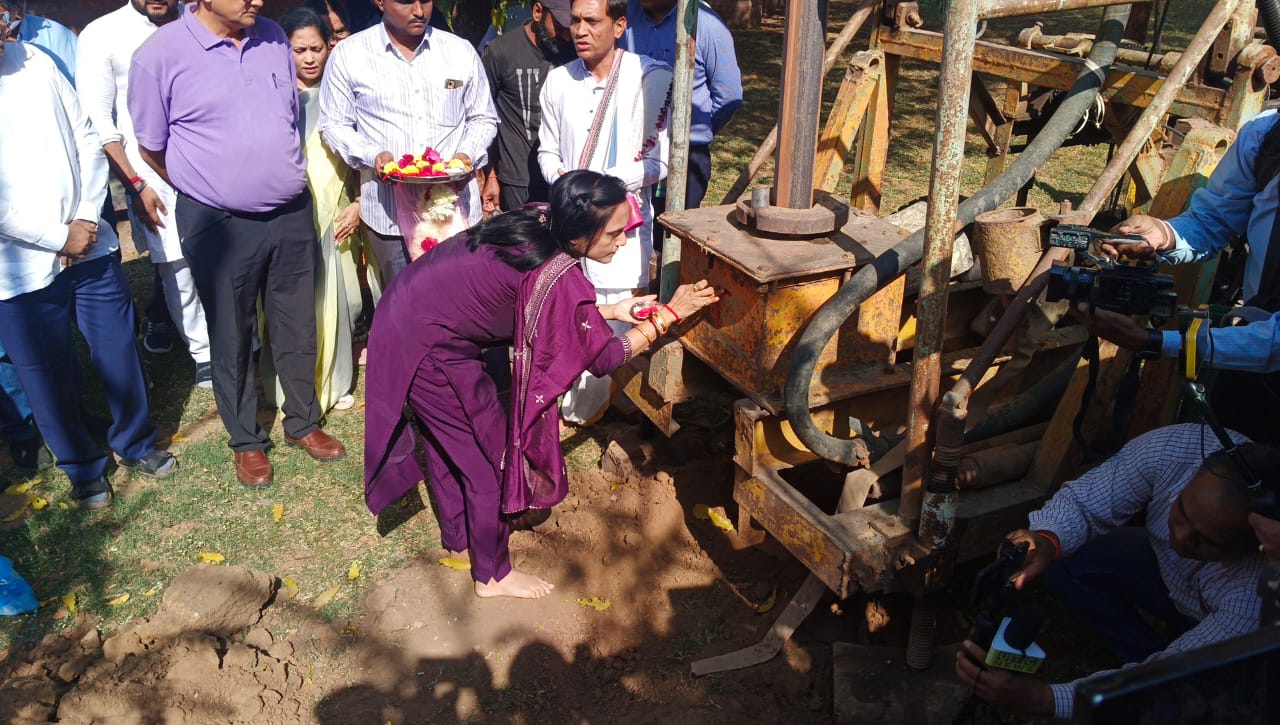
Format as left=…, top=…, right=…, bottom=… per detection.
left=1069, top=0, right=1239, bottom=224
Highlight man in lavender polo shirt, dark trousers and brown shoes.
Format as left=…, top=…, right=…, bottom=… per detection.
left=129, top=0, right=346, bottom=487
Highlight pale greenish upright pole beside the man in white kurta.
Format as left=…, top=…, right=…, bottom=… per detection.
left=658, top=0, right=698, bottom=300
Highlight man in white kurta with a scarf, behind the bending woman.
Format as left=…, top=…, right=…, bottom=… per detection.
left=538, top=0, right=671, bottom=425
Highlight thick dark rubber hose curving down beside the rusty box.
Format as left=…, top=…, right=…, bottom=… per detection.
left=783, top=5, right=1129, bottom=466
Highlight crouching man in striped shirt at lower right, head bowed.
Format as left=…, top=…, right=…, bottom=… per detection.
left=956, top=424, right=1280, bottom=719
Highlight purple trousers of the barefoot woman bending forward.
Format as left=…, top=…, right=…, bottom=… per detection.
left=408, top=356, right=511, bottom=583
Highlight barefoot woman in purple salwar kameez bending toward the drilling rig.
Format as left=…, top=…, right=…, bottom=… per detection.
left=365, top=172, right=717, bottom=598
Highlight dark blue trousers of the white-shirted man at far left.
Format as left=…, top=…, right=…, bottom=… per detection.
left=0, top=255, right=156, bottom=485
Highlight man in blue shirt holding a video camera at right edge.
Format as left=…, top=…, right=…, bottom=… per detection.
left=1076, top=111, right=1280, bottom=443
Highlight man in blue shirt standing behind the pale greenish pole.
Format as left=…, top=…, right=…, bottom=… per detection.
left=622, top=0, right=742, bottom=208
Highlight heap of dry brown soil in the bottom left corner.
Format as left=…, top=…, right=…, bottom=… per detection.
left=0, top=565, right=308, bottom=722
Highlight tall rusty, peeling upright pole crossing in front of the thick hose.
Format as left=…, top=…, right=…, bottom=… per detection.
left=897, top=0, right=979, bottom=520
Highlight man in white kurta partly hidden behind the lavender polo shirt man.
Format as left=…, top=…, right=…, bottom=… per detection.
left=76, top=0, right=212, bottom=388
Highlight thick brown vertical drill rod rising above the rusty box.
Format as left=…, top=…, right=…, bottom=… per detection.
left=773, top=0, right=824, bottom=209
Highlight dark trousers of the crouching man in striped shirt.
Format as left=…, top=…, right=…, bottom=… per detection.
left=1044, top=526, right=1196, bottom=662
